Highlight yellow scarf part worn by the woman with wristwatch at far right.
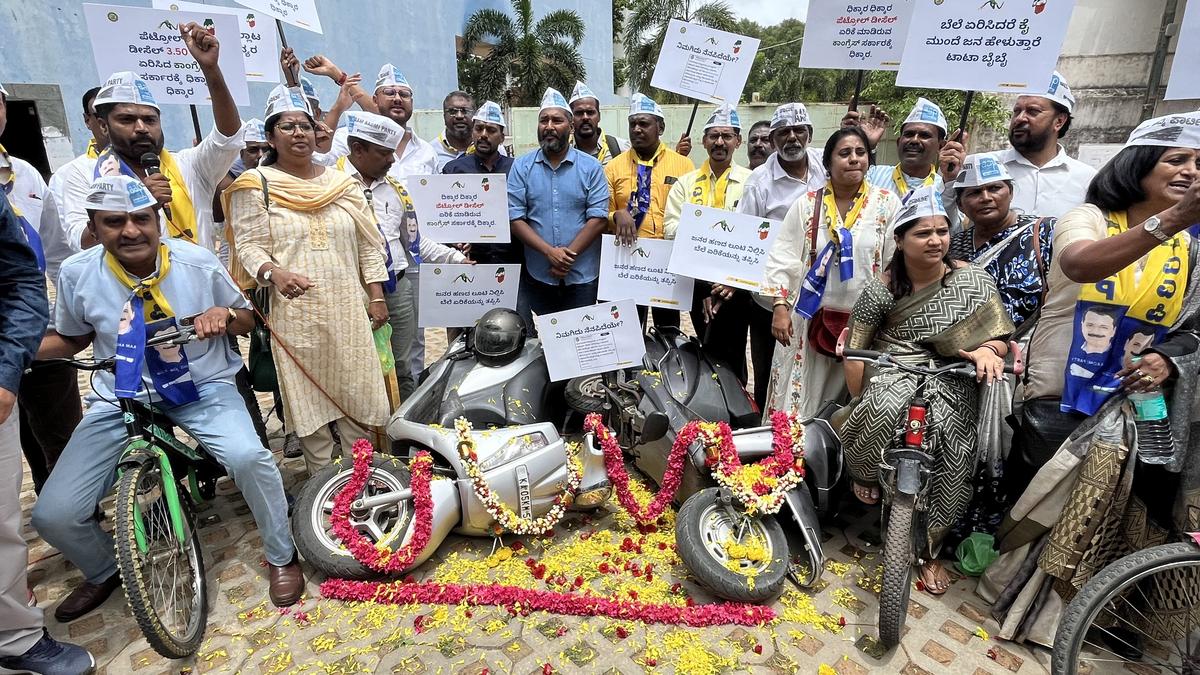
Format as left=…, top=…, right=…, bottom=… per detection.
left=1079, top=211, right=1188, bottom=328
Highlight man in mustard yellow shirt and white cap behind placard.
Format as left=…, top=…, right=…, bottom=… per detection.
left=604, top=94, right=696, bottom=327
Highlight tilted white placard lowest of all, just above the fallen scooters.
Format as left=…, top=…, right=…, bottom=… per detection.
left=537, top=297, right=646, bottom=382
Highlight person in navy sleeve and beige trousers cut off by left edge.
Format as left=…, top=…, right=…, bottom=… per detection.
left=0, top=193, right=96, bottom=674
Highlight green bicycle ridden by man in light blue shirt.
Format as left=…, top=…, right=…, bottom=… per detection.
left=32, top=325, right=224, bottom=658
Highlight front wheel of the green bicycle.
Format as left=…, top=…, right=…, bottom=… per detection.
left=113, top=461, right=209, bottom=658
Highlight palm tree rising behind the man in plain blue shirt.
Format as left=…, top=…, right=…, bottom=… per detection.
left=462, top=0, right=587, bottom=106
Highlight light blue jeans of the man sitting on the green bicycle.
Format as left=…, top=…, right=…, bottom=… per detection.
left=32, top=382, right=295, bottom=584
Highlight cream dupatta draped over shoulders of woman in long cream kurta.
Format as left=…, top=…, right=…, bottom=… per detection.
left=221, top=167, right=384, bottom=288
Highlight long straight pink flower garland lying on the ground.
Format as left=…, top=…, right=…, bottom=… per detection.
left=320, top=571, right=775, bottom=627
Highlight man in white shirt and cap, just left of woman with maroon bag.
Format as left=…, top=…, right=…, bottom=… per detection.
left=738, top=103, right=827, bottom=220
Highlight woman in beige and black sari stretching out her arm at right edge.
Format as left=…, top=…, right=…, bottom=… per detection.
left=978, top=115, right=1200, bottom=646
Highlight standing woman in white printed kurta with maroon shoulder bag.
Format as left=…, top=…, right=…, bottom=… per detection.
left=756, top=126, right=900, bottom=418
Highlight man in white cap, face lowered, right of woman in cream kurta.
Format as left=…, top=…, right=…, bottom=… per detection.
left=337, top=112, right=467, bottom=399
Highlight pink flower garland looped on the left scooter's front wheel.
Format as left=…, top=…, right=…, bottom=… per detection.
left=329, top=438, right=433, bottom=574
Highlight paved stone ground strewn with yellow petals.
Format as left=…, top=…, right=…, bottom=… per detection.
left=22, top=330, right=1070, bottom=675
